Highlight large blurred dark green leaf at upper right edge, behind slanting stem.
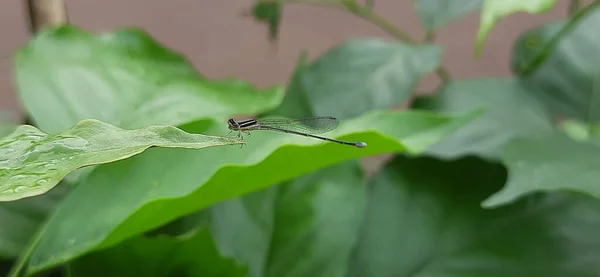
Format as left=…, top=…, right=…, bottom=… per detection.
left=512, top=6, right=600, bottom=123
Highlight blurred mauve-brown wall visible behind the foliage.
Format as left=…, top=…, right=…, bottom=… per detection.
left=0, top=0, right=589, bottom=123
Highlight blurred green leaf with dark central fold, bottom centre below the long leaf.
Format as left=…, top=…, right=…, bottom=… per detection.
left=212, top=161, right=366, bottom=277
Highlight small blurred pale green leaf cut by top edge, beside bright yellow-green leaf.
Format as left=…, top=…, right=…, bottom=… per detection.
left=413, top=0, right=483, bottom=31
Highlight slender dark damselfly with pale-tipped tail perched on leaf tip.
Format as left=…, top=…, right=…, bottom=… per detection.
left=227, top=116, right=367, bottom=148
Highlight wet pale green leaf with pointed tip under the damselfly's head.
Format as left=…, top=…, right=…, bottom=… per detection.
left=0, top=119, right=242, bottom=201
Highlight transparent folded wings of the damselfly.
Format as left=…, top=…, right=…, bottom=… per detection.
left=257, top=116, right=340, bottom=135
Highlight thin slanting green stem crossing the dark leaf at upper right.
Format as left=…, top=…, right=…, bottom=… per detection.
left=521, top=0, right=600, bottom=77
